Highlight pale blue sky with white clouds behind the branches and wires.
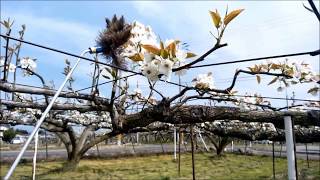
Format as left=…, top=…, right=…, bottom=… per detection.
left=1, top=1, right=319, bottom=109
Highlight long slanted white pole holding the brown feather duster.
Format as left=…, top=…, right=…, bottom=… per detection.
left=3, top=50, right=89, bottom=180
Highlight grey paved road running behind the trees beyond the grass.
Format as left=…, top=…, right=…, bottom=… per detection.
left=0, top=144, right=319, bottom=162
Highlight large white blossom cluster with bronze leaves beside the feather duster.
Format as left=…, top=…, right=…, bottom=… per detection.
left=122, top=21, right=195, bottom=82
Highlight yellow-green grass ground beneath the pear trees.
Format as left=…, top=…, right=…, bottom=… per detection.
left=0, top=153, right=320, bottom=180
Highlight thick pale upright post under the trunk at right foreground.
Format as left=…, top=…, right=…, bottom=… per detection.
left=284, top=116, right=296, bottom=180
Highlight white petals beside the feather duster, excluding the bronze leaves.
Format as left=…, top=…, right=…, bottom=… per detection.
left=122, top=21, right=191, bottom=81
